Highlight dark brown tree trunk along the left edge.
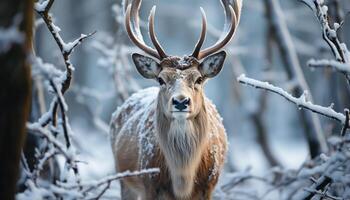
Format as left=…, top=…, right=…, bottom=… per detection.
left=0, top=0, right=33, bottom=200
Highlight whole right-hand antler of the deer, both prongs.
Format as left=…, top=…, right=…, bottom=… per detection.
left=192, top=0, right=243, bottom=59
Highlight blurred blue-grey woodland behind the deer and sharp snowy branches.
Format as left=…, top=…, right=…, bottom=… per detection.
left=27, top=0, right=350, bottom=197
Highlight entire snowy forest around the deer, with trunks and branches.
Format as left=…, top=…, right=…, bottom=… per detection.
left=0, top=0, right=350, bottom=200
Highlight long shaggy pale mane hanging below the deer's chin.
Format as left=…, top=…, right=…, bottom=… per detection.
left=156, top=94, right=208, bottom=198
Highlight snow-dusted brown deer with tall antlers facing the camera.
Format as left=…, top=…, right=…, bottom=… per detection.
left=110, top=0, right=242, bottom=200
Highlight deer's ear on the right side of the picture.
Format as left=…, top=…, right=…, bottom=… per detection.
left=199, top=51, right=226, bottom=78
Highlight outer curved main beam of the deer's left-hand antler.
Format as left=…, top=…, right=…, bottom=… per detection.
left=125, top=0, right=161, bottom=59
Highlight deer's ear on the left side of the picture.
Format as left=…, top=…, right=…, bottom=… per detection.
left=132, top=53, right=161, bottom=79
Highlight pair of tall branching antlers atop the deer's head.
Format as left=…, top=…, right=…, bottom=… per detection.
left=125, top=0, right=243, bottom=60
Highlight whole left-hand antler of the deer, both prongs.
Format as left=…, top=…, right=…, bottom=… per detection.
left=125, top=0, right=168, bottom=60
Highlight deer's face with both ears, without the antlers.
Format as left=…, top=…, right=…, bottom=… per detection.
left=132, top=51, right=226, bottom=119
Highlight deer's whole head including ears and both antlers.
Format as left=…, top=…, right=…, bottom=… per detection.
left=125, top=0, right=241, bottom=119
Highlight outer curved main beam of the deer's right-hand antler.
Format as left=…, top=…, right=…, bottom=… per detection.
left=198, top=0, right=242, bottom=59
